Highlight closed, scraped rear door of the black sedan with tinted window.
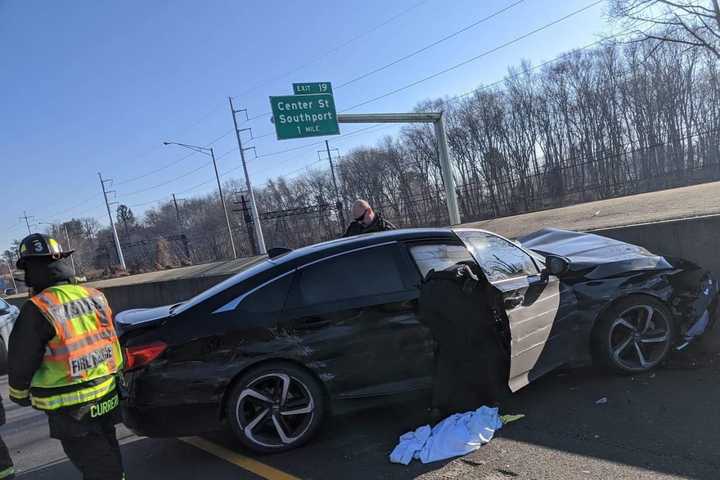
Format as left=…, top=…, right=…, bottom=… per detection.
left=280, top=242, right=427, bottom=399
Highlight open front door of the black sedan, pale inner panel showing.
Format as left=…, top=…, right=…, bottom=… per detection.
left=456, top=230, right=566, bottom=391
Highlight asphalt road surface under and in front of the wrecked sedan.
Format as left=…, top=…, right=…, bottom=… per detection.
left=0, top=329, right=720, bottom=480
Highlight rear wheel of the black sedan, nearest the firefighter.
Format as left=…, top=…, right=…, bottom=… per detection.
left=225, top=362, right=325, bottom=453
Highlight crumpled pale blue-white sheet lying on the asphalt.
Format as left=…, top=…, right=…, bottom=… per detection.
left=390, top=407, right=503, bottom=465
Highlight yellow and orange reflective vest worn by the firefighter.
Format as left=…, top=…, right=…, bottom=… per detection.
left=30, top=285, right=122, bottom=410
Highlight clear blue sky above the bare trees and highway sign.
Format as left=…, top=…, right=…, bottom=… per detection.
left=0, top=0, right=609, bottom=250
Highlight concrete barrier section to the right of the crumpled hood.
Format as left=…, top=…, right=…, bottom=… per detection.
left=593, top=215, right=720, bottom=279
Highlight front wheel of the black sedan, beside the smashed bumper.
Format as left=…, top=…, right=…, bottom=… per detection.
left=591, top=295, right=676, bottom=374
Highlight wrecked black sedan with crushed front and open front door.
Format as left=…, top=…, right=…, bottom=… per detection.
left=116, top=229, right=718, bottom=452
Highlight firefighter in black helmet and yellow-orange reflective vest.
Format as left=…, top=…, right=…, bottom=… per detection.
left=8, top=233, right=125, bottom=480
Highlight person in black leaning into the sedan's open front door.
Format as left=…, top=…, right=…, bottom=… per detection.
left=419, top=263, right=507, bottom=421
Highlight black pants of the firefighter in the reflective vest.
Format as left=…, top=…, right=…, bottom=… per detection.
left=60, top=425, right=125, bottom=480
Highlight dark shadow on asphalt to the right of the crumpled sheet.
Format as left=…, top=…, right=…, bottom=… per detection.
left=484, top=328, right=720, bottom=479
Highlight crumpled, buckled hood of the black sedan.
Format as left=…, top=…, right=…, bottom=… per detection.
left=518, top=228, right=673, bottom=279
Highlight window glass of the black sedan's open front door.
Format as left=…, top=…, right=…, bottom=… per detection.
left=459, top=232, right=539, bottom=282
